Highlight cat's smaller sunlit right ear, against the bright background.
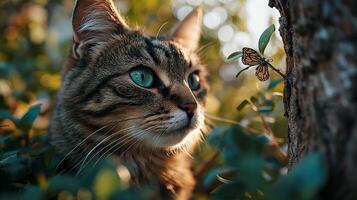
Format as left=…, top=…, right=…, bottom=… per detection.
left=169, top=6, right=203, bottom=51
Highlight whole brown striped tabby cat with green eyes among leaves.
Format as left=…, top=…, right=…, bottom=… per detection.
left=50, top=0, right=208, bottom=199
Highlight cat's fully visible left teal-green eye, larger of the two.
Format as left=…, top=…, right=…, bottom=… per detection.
left=130, top=67, right=154, bottom=88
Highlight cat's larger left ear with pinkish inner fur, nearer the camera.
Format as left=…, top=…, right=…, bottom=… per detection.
left=72, top=0, right=129, bottom=58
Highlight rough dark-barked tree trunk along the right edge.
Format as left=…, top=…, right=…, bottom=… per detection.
left=269, top=0, right=357, bottom=200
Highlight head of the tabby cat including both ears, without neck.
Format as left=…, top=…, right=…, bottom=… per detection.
left=58, top=0, right=208, bottom=153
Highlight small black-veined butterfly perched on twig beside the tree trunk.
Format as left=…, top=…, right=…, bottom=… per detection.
left=236, top=47, right=285, bottom=81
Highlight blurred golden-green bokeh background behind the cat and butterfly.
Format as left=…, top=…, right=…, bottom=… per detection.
left=0, top=0, right=287, bottom=198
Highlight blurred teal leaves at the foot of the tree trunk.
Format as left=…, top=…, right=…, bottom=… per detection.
left=205, top=126, right=326, bottom=200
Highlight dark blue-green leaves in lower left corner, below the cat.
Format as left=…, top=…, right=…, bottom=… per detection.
left=0, top=105, right=156, bottom=199
